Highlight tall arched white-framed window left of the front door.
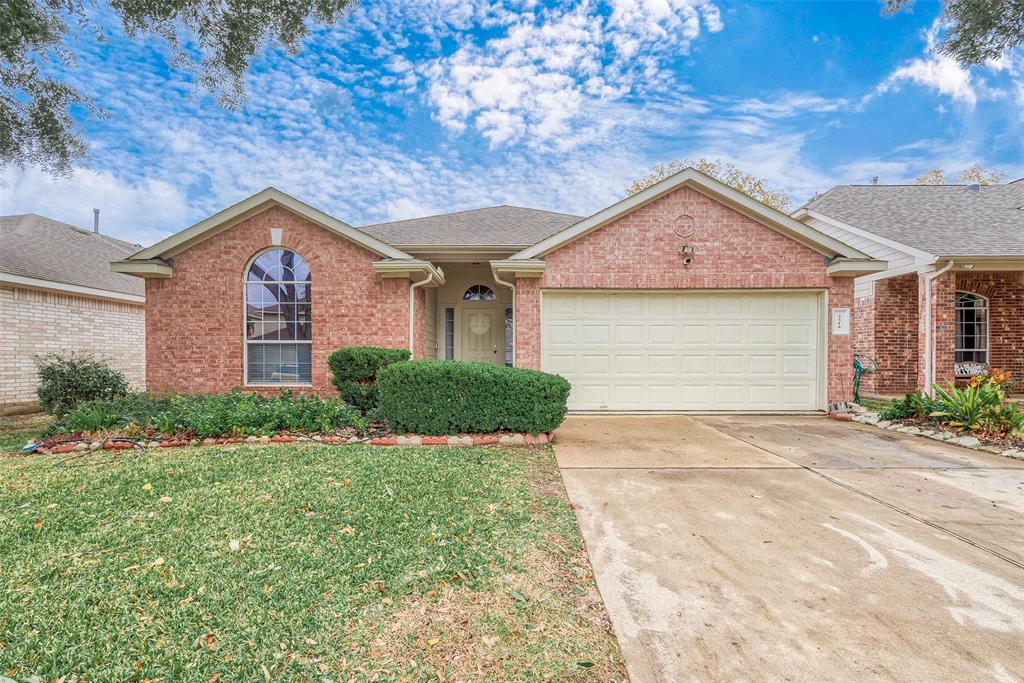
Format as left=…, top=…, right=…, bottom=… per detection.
left=245, top=249, right=312, bottom=385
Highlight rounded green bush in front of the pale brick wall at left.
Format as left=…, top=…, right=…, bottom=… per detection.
left=34, top=353, right=129, bottom=417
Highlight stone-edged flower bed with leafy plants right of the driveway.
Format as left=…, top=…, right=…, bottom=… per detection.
left=853, top=370, right=1024, bottom=458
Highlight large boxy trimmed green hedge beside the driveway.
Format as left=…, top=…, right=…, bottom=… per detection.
left=377, top=360, right=569, bottom=435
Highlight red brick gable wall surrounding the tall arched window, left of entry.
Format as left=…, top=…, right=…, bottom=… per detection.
left=145, top=207, right=409, bottom=393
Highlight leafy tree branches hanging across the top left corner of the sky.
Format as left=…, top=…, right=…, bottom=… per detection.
left=0, top=0, right=355, bottom=175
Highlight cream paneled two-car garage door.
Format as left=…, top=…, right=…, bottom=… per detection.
left=541, top=290, right=823, bottom=411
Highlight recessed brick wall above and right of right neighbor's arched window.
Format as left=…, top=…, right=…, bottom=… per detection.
left=956, top=272, right=1024, bottom=376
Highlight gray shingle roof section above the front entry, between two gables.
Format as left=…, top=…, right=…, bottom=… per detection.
left=359, top=205, right=582, bottom=248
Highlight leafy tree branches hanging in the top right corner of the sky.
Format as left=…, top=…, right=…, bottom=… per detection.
left=886, top=0, right=1024, bottom=66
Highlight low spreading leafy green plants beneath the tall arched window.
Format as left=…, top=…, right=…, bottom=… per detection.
left=47, top=390, right=368, bottom=438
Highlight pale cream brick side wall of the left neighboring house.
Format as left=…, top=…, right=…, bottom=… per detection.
left=0, top=288, right=145, bottom=412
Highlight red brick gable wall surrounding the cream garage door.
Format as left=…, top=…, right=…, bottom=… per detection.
left=516, top=187, right=853, bottom=401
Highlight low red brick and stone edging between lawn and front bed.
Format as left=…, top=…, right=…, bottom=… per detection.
left=25, top=432, right=553, bottom=455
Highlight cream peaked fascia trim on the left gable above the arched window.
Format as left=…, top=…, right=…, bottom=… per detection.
left=127, top=187, right=410, bottom=260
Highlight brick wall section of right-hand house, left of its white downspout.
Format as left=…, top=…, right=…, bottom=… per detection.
left=857, top=273, right=921, bottom=394
